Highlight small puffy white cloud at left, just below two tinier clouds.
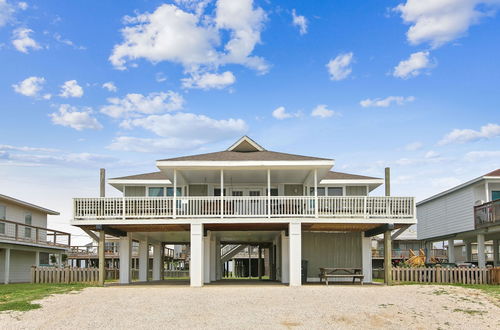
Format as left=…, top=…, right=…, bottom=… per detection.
left=50, top=104, right=102, bottom=131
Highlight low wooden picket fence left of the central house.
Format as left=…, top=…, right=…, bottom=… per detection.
left=31, top=267, right=119, bottom=283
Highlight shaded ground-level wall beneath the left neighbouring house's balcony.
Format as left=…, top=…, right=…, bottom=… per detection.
left=0, top=249, right=35, bottom=283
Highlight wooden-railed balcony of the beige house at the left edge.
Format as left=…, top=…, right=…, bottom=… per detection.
left=0, top=219, right=71, bottom=249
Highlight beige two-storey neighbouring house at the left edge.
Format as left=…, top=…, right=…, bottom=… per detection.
left=0, top=195, right=71, bottom=284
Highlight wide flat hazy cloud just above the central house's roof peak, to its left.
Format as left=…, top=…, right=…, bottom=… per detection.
left=121, top=112, right=247, bottom=141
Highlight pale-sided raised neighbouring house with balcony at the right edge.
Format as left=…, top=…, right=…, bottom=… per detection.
left=417, top=169, right=500, bottom=267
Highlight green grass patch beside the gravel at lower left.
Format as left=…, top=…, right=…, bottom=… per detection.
left=0, top=284, right=89, bottom=311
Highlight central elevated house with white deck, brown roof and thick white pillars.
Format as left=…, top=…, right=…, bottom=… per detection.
left=71, top=136, right=416, bottom=286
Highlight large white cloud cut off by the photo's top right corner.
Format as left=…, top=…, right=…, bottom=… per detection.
left=394, top=0, right=500, bottom=48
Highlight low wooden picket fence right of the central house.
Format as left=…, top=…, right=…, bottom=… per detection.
left=392, top=267, right=500, bottom=284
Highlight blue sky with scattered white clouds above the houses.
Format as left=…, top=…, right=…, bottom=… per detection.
left=0, top=0, right=500, bottom=242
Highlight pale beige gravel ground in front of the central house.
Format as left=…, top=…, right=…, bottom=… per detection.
left=0, top=285, right=500, bottom=329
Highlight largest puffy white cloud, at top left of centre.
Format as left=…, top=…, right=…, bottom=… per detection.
left=109, top=0, right=268, bottom=73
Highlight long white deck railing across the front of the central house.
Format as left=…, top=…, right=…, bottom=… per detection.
left=74, top=196, right=415, bottom=220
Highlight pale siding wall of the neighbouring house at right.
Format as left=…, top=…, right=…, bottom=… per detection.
left=417, top=187, right=475, bottom=239
